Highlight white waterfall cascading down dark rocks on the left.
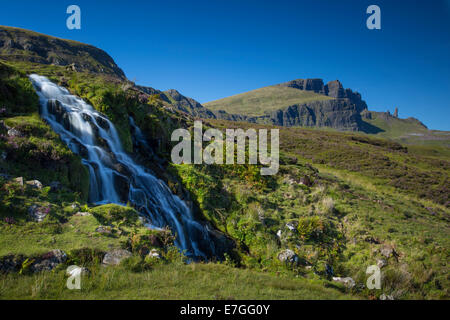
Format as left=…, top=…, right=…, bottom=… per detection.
left=30, top=75, right=215, bottom=258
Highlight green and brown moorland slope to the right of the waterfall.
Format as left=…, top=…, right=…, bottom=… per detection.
left=174, top=121, right=450, bottom=299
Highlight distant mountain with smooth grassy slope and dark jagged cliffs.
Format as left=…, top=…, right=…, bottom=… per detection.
left=205, top=79, right=370, bottom=132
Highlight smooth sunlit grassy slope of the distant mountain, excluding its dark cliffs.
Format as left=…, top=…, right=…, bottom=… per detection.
left=204, top=86, right=332, bottom=116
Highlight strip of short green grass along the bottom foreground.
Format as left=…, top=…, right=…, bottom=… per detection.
left=0, top=263, right=354, bottom=300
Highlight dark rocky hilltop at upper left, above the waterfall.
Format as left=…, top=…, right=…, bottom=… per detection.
left=0, top=26, right=125, bottom=79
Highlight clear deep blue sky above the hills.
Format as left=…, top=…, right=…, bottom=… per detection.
left=0, top=0, right=450, bottom=130
